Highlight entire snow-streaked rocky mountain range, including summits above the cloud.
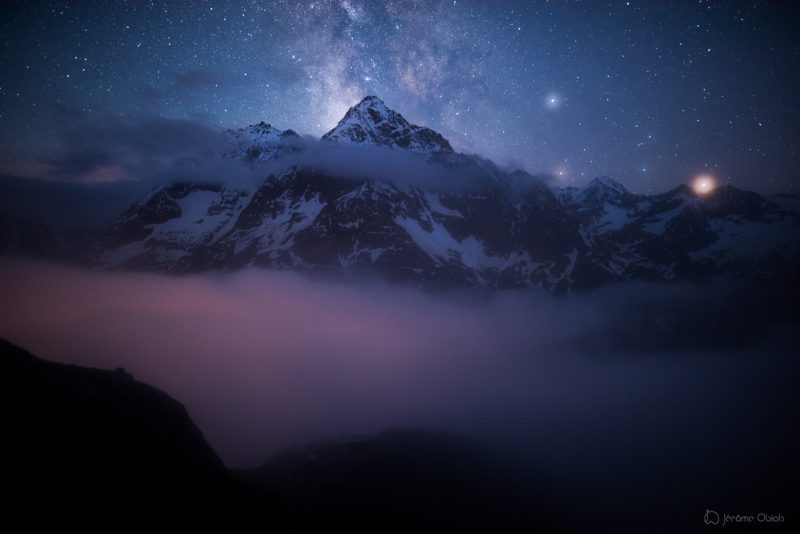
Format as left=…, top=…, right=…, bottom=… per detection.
left=32, top=97, right=800, bottom=293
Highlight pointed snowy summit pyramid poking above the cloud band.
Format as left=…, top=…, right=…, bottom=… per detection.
left=322, top=96, right=453, bottom=154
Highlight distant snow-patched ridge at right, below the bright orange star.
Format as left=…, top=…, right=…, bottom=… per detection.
left=559, top=178, right=800, bottom=280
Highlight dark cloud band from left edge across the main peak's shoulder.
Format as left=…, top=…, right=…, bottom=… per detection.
left=0, top=109, right=535, bottom=230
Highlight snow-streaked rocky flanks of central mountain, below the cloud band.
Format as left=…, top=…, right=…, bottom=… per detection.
left=98, top=166, right=581, bottom=294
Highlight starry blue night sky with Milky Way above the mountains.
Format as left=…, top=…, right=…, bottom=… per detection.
left=0, top=0, right=800, bottom=193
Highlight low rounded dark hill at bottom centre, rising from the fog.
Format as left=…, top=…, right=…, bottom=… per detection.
left=234, top=429, right=553, bottom=533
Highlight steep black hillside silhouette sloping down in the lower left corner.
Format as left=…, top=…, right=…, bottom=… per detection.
left=0, top=340, right=276, bottom=532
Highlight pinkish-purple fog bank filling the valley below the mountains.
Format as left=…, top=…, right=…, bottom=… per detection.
left=0, top=259, right=800, bottom=530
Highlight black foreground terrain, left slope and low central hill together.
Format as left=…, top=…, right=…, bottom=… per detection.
left=0, top=340, right=549, bottom=533
